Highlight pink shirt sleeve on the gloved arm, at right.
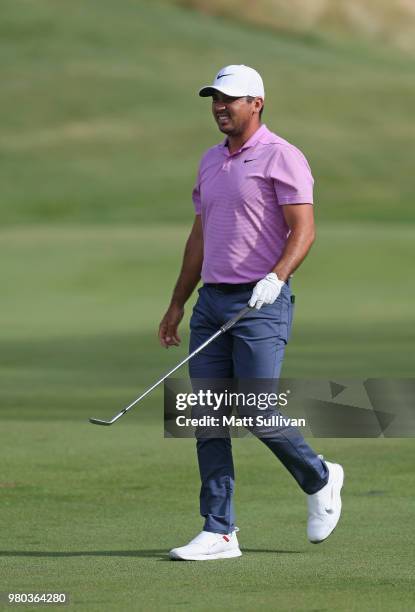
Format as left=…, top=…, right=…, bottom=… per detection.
left=270, top=146, right=314, bottom=205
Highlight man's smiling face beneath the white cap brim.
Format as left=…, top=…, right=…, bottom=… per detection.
left=212, top=91, right=258, bottom=136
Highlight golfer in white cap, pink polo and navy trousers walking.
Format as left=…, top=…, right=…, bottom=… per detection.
left=159, top=65, right=343, bottom=560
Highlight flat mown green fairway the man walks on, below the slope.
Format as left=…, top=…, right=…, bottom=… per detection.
left=0, top=224, right=415, bottom=612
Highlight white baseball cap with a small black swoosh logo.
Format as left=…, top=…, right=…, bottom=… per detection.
left=199, top=64, right=265, bottom=100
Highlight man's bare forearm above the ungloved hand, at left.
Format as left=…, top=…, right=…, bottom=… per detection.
left=171, top=218, right=203, bottom=307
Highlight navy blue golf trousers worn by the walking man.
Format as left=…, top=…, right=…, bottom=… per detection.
left=189, top=284, right=328, bottom=533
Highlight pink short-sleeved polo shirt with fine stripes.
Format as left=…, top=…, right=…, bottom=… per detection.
left=193, top=125, right=314, bottom=283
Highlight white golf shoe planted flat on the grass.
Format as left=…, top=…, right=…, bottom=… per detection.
left=169, top=528, right=242, bottom=561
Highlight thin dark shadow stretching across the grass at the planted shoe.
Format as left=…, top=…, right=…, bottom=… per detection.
left=0, top=548, right=304, bottom=559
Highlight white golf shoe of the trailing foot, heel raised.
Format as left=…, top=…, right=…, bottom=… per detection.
left=307, top=455, right=344, bottom=544
